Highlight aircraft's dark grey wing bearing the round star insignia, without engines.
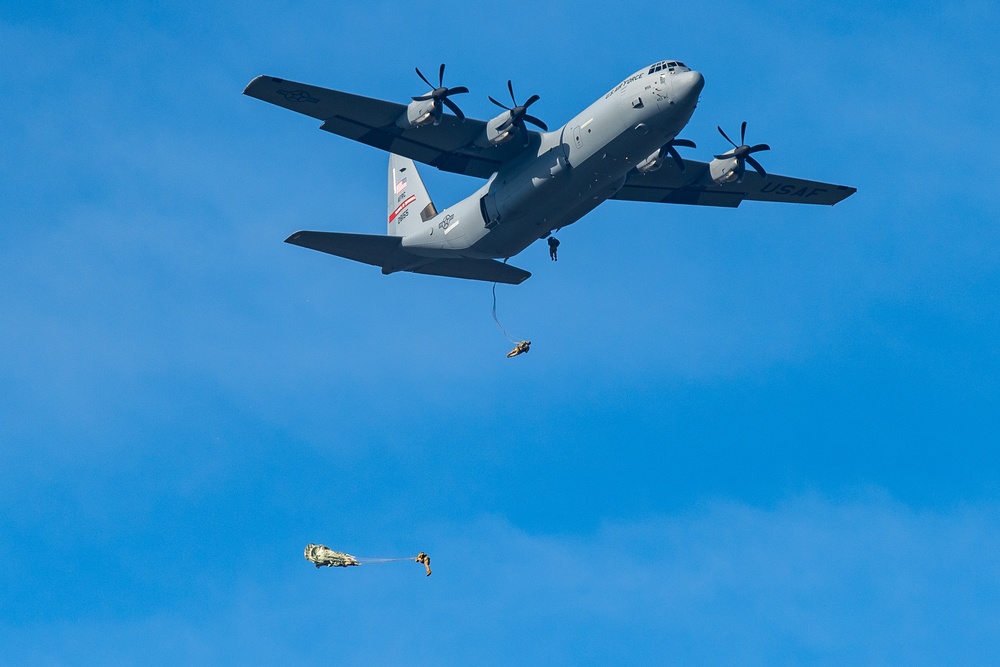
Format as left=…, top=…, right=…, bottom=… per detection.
left=243, top=76, right=538, bottom=178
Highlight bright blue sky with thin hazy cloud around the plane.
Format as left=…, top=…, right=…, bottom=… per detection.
left=0, top=1, right=1000, bottom=665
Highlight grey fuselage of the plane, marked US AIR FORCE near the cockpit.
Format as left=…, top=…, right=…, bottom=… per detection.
left=386, top=66, right=704, bottom=272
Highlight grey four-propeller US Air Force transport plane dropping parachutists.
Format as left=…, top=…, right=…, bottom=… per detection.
left=243, top=60, right=856, bottom=284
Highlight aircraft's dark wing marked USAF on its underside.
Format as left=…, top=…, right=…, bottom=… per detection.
left=613, top=160, right=858, bottom=208
